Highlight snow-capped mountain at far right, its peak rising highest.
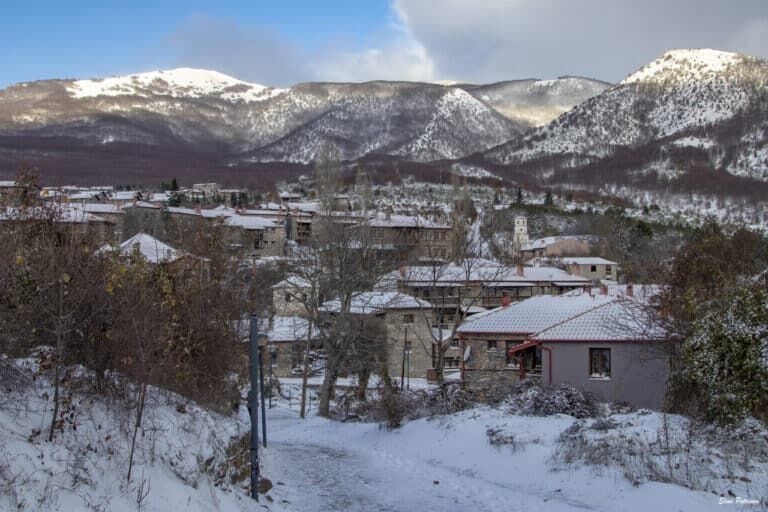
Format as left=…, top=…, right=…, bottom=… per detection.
left=486, top=50, right=768, bottom=181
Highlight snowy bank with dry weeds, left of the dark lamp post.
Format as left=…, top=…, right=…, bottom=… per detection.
left=0, top=361, right=264, bottom=512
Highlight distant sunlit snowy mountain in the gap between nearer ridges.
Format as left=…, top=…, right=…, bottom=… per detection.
left=464, top=77, right=611, bottom=128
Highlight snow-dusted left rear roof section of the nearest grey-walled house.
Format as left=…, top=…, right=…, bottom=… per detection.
left=458, top=286, right=657, bottom=339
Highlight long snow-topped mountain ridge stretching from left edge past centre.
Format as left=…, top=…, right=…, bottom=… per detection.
left=0, top=68, right=526, bottom=163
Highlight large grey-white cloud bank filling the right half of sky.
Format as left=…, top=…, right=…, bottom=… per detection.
left=393, top=0, right=768, bottom=81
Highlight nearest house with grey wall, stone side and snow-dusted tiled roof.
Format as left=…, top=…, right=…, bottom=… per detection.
left=458, top=285, right=669, bottom=409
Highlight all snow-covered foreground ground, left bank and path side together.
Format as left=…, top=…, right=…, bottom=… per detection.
left=0, top=362, right=768, bottom=512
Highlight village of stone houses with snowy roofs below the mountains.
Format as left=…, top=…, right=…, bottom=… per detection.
left=2, top=176, right=669, bottom=409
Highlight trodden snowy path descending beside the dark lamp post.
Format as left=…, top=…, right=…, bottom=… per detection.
left=265, top=409, right=594, bottom=512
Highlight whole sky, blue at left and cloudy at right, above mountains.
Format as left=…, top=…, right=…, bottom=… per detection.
left=0, top=0, right=768, bottom=87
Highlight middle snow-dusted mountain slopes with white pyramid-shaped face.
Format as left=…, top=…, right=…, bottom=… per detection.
left=246, top=82, right=522, bottom=163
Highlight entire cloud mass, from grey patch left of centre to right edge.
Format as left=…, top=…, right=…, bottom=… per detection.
left=165, top=0, right=768, bottom=86
